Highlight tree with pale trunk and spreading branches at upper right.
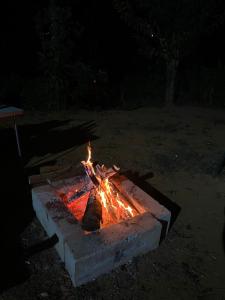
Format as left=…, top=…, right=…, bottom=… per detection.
left=112, top=0, right=225, bottom=107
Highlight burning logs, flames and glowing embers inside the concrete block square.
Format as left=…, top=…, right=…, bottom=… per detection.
left=49, top=143, right=140, bottom=231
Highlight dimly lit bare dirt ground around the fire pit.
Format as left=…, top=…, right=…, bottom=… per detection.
left=0, top=107, right=225, bottom=300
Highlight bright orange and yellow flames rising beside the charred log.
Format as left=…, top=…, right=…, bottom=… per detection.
left=81, top=143, right=137, bottom=227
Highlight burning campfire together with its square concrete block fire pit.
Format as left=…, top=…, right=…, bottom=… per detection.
left=32, top=144, right=171, bottom=286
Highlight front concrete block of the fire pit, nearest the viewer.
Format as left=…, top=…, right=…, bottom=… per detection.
left=65, top=213, right=162, bottom=286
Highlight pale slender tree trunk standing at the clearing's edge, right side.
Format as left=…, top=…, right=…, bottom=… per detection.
left=165, top=59, right=179, bottom=107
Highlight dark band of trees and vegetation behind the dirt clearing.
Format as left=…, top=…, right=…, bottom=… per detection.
left=0, top=0, right=225, bottom=110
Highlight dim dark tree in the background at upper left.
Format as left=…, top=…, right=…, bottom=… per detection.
left=36, top=0, right=82, bottom=109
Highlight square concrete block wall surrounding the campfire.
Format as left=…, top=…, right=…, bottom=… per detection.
left=32, top=175, right=171, bottom=286
